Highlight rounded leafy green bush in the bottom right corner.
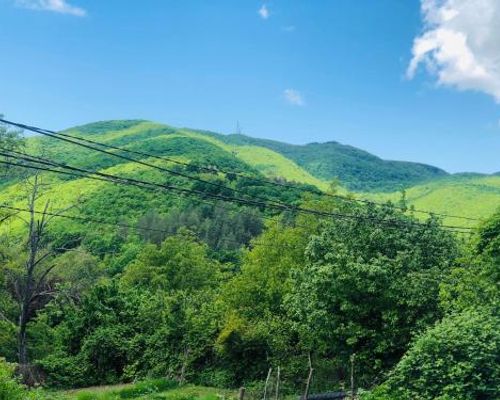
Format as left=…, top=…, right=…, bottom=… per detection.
left=386, top=310, right=500, bottom=400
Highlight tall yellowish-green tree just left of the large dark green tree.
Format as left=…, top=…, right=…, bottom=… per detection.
left=216, top=225, right=308, bottom=382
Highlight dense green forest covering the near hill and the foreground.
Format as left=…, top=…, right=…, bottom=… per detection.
left=0, top=121, right=500, bottom=400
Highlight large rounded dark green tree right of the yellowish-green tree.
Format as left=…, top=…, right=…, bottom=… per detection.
left=287, top=207, right=458, bottom=385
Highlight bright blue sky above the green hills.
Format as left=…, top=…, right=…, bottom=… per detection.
left=0, top=0, right=500, bottom=173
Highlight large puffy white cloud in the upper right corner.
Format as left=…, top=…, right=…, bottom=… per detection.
left=407, top=0, right=500, bottom=102
